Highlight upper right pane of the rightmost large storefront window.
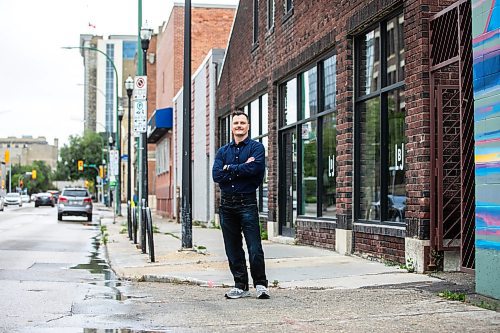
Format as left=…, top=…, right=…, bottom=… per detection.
left=387, top=14, right=405, bottom=85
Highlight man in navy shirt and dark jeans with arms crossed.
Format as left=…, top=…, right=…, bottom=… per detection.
left=212, top=110, right=269, bottom=299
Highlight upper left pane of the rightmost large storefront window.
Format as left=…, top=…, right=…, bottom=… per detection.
left=358, top=28, right=380, bottom=96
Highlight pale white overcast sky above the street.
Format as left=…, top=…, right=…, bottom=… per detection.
left=0, top=0, right=238, bottom=146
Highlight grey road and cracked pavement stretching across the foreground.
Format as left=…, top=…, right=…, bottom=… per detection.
left=0, top=204, right=500, bottom=333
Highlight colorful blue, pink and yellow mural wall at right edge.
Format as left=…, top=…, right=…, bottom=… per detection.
left=472, top=0, right=500, bottom=299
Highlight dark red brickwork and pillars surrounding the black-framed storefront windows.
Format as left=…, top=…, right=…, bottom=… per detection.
left=217, top=0, right=464, bottom=252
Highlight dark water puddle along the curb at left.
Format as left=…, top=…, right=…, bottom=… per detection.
left=70, top=232, right=125, bottom=300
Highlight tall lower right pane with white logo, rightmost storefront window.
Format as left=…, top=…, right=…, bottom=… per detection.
left=385, top=89, right=406, bottom=222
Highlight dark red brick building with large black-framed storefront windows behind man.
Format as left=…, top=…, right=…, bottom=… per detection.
left=217, top=0, right=472, bottom=271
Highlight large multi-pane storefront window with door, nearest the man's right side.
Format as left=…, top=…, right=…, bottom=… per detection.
left=278, top=56, right=337, bottom=235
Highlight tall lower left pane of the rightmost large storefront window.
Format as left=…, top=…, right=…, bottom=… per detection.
left=357, top=97, right=380, bottom=219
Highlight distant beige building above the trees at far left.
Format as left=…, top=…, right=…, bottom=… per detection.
left=0, top=136, right=59, bottom=170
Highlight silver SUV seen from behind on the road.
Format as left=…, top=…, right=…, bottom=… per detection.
left=57, top=187, right=92, bottom=222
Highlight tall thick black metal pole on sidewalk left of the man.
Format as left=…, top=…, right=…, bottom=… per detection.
left=181, top=0, right=193, bottom=249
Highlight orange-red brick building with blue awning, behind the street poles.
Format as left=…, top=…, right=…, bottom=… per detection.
left=149, top=4, right=235, bottom=217
